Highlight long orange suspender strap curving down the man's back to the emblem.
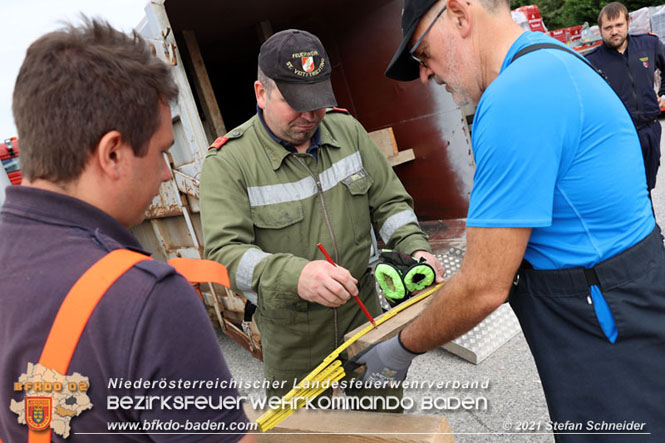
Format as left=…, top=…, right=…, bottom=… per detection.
left=28, top=249, right=152, bottom=443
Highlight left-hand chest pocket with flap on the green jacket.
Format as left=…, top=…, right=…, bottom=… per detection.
left=251, top=201, right=305, bottom=252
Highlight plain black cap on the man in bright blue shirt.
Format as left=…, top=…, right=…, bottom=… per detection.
left=386, top=0, right=437, bottom=81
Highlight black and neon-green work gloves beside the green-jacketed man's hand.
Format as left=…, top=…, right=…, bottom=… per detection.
left=374, top=249, right=436, bottom=306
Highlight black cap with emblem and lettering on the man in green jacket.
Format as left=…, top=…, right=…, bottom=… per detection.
left=259, top=29, right=337, bottom=112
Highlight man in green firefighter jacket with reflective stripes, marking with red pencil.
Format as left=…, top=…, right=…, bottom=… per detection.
left=200, top=30, right=443, bottom=395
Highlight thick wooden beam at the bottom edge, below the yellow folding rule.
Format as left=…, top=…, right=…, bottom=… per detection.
left=245, top=404, right=455, bottom=443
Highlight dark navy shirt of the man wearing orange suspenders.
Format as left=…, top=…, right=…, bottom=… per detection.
left=0, top=186, right=247, bottom=443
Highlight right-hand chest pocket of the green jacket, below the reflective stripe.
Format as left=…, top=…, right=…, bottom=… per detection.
left=342, top=169, right=374, bottom=243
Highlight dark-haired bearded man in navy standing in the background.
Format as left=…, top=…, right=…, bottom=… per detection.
left=587, top=2, right=665, bottom=191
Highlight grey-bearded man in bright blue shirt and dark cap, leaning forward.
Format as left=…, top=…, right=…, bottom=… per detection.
left=356, top=0, right=665, bottom=441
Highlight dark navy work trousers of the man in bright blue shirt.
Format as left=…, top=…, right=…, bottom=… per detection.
left=509, top=226, right=665, bottom=442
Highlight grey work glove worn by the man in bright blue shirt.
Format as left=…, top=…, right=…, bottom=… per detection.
left=349, top=335, right=421, bottom=385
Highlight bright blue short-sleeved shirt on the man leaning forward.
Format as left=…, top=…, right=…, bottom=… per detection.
left=467, top=32, right=655, bottom=269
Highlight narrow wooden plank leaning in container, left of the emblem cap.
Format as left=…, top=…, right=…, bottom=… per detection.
left=182, top=30, right=226, bottom=136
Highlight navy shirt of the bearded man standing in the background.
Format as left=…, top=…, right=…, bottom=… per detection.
left=586, top=34, right=665, bottom=127
